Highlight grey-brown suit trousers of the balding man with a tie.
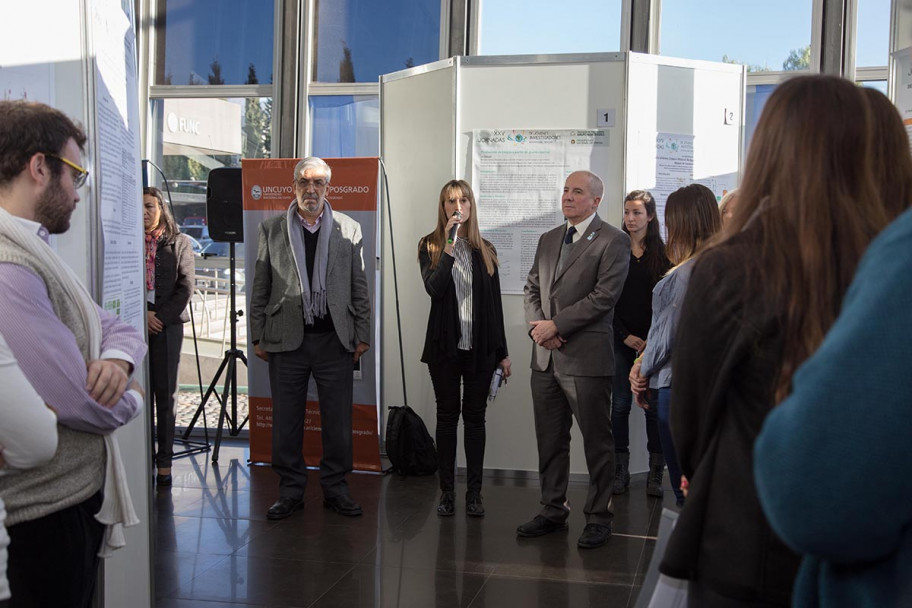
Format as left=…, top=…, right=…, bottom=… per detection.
left=532, top=363, right=614, bottom=524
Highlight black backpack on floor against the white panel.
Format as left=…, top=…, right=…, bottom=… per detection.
left=386, top=405, right=437, bottom=475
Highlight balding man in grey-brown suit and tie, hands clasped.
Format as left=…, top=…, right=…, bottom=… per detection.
left=516, top=171, right=630, bottom=549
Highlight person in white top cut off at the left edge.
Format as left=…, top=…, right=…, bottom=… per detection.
left=0, top=334, right=57, bottom=605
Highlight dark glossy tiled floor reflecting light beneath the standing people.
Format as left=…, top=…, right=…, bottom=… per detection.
left=154, top=441, right=674, bottom=608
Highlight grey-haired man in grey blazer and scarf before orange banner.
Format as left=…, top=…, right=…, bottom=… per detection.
left=250, top=157, right=370, bottom=519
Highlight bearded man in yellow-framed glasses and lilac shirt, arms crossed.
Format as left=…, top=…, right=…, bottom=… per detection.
left=0, top=101, right=146, bottom=606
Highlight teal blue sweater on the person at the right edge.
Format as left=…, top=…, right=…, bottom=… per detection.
left=754, top=210, right=912, bottom=608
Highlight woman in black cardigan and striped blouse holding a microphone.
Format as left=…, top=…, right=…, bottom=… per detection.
left=418, top=180, right=510, bottom=517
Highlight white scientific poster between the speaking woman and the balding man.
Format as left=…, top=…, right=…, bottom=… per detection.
left=472, top=129, right=609, bottom=294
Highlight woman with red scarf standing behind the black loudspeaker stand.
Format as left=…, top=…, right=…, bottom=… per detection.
left=143, top=188, right=196, bottom=486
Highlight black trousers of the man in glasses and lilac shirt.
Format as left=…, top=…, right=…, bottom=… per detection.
left=6, top=492, right=104, bottom=608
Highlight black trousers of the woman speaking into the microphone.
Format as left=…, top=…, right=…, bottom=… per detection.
left=428, top=350, right=494, bottom=492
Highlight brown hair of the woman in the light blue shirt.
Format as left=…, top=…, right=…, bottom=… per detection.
left=665, top=184, right=722, bottom=266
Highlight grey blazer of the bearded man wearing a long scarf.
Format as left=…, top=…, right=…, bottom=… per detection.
left=249, top=210, right=371, bottom=352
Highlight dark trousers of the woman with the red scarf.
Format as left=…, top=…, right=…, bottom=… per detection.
left=149, top=324, right=184, bottom=469
